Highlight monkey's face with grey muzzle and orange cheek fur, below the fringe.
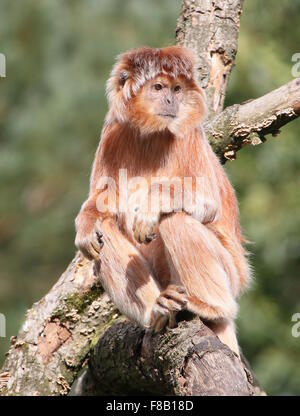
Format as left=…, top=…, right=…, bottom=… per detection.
left=129, top=75, right=204, bottom=136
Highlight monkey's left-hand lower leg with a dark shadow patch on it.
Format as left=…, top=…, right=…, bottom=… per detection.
left=96, top=219, right=166, bottom=327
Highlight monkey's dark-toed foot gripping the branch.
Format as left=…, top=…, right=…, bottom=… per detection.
left=150, top=285, right=187, bottom=332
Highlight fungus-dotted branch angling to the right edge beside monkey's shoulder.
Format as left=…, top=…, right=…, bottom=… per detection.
left=205, top=78, right=300, bottom=162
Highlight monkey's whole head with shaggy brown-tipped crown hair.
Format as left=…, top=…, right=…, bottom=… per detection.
left=107, top=46, right=206, bottom=136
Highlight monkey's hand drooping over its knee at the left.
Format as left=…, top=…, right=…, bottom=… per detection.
left=75, top=221, right=103, bottom=260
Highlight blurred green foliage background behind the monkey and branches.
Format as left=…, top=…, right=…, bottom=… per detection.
left=0, top=0, right=300, bottom=394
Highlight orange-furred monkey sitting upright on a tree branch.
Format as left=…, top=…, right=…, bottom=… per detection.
left=75, top=46, right=251, bottom=356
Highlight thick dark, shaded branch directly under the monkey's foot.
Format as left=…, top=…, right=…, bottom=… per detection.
left=71, top=318, right=264, bottom=396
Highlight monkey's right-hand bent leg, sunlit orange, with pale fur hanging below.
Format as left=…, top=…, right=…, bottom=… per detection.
left=159, top=213, right=238, bottom=354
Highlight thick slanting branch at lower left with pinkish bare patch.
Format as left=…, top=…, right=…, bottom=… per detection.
left=0, top=253, right=119, bottom=396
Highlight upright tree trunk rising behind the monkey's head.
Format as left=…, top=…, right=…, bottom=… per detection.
left=176, top=0, right=243, bottom=118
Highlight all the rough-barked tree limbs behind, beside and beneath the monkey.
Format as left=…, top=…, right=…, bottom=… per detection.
left=0, top=0, right=300, bottom=395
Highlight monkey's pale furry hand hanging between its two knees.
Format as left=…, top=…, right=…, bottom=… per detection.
left=132, top=210, right=160, bottom=243
